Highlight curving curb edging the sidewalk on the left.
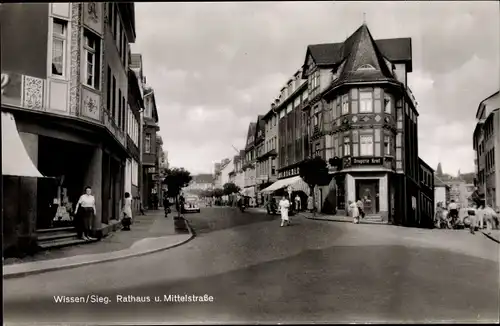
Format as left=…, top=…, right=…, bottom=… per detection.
left=3, top=219, right=196, bottom=280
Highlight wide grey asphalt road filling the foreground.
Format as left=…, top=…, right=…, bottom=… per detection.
left=4, top=208, right=500, bottom=324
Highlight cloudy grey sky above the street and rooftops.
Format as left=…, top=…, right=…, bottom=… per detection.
left=132, top=1, right=500, bottom=175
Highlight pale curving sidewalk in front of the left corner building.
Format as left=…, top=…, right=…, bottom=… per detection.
left=3, top=210, right=194, bottom=279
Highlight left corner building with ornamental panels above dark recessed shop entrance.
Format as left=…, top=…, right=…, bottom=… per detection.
left=0, top=3, right=139, bottom=255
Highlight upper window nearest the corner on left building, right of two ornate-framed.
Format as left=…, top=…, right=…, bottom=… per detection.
left=83, top=29, right=101, bottom=89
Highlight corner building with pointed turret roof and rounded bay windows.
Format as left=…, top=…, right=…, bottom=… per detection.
left=304, top=24, right=433, bottom=226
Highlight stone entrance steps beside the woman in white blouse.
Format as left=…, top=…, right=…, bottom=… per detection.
left=37, top=227, right=98, bottom=250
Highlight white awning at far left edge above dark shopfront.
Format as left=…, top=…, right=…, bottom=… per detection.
left=2, top=112, right=43, bottom=178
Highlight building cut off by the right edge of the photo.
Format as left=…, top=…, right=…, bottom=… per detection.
left=473, top=92, right=500, bottom=208
